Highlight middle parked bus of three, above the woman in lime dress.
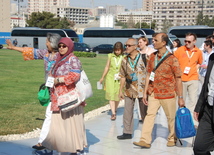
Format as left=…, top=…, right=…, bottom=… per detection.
left=83, top=28, right=155, bottom=47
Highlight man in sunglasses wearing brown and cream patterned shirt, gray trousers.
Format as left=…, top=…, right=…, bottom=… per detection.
left=117, top=38, right=147, bottom=140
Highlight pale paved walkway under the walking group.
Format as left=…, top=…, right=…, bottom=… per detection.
left=0, top=104, right=214, bottom=155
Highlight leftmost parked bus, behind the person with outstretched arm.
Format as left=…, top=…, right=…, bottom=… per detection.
left=11, top=27, right=78, bottom=49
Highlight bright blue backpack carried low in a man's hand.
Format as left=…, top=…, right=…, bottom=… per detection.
left=175, top=107, right=196, bottom=139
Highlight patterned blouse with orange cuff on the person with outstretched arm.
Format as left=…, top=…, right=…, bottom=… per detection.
left=22, top=47, right=57, bottom=81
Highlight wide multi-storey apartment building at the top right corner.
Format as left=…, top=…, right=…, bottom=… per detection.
left=152, top=0, right=214, bottom=32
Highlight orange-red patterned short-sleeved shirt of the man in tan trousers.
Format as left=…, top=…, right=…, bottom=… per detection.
left=147, top=53, right=182, bottom=99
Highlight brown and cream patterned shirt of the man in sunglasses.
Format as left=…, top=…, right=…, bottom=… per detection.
left=120, top=54, right=146, bottom=98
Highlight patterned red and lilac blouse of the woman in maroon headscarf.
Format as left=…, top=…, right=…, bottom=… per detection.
left=51, top=55, right=81, bottom=111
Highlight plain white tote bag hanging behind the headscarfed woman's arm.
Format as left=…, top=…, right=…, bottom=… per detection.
left=76, top=70, right=93, bottom=102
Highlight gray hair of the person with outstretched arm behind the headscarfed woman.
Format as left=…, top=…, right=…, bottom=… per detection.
left=47, top=33, right=61, bottom=51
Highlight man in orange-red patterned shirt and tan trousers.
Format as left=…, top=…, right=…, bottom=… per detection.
left=133, top=33, right=184, bottom=148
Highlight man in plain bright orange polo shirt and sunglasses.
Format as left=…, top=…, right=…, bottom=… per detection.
left=174, top=33, right=203, bottom=125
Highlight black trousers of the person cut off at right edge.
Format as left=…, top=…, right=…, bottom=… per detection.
left=193, top=103, right=214, bottom=155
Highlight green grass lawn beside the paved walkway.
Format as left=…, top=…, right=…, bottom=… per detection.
left=0, top=49, right=108, bottom=135
